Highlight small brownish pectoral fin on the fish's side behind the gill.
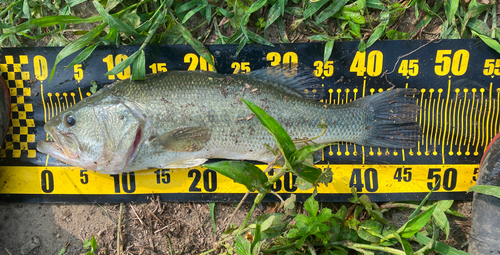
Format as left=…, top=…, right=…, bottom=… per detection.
left=155, top=127, right=211, bottom=152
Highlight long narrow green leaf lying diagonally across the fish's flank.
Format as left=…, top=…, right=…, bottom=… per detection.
left=241, top=99, right=296, bottom=160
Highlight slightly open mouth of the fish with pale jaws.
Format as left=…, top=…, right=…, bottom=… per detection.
left=36, top=128, right=80, bottom=160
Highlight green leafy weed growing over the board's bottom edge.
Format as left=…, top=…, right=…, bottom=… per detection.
left=204, top=100, right=467, bottom=255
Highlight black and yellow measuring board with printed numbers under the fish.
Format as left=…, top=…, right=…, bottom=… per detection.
left=0, top=39, right=500, bottom=203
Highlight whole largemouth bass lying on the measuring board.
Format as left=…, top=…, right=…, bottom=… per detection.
left=37, top=69, right=420, bottom=174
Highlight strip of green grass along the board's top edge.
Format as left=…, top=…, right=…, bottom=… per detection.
left=0, top=0, right=500, bottom=80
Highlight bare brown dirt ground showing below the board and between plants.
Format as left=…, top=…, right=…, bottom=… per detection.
left=0, top=2, right=478, bottom=255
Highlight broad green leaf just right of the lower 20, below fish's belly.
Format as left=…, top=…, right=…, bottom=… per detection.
left=203, top=161, right=269, bottom=193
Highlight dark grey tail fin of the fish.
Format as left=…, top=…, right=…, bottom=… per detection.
left=361, top=89, right=421, bottom=149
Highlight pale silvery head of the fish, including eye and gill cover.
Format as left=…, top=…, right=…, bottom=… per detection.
left=37, top=95, right=144, bottom=173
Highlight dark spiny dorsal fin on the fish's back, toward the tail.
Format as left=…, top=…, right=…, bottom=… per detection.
left=246, top=65, right=325, bottom=100
